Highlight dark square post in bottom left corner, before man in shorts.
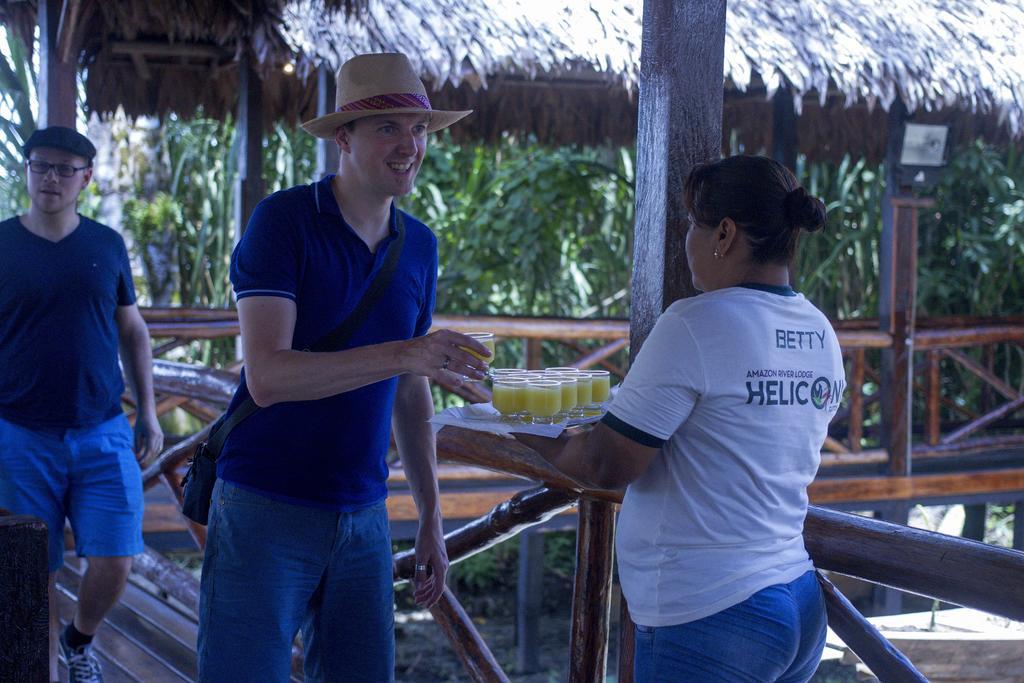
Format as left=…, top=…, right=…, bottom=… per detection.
left=0, top=511, right=50, bottom=681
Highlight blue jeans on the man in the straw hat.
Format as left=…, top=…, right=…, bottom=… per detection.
left=198, top=481, right=394, bottom=683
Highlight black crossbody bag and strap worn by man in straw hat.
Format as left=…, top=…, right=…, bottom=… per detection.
left=181, top=210, right=406, bottom=525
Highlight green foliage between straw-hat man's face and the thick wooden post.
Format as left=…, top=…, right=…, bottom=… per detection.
left=403, top=135, right=634, bottom=316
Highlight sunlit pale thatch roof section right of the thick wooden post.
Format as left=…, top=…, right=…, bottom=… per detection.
left=726, top=0, right=1024, bottom=127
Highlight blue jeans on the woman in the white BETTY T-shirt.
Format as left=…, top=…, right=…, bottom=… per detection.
left=634, top=571, right=827, bottom=683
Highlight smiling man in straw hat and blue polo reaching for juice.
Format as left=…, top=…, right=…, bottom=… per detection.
left=199, top=54, right=489, bottom=683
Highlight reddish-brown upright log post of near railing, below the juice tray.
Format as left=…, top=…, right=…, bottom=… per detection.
left=568, top=498, right=615, bottom=683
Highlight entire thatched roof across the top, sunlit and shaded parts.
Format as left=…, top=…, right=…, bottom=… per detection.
left=0, top=0, right=1024, bottom=156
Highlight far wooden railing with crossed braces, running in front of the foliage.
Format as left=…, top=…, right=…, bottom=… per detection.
left=143, top=308, right=1024, bottom=466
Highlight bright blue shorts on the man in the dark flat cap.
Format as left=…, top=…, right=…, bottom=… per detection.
left=0, top=415, right=143, bottom=571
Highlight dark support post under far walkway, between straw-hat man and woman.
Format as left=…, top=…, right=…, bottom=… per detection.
left=515, top=529, right=544, bottom=674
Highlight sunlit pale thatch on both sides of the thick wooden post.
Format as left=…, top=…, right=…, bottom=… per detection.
left=286, top=0, right=1024, bottom=131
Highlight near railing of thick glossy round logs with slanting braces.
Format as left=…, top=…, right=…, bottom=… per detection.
left=130, top=344, right=1024, bottom=681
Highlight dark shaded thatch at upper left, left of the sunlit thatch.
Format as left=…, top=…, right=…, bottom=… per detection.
left=0, top=0, right=370, bottom=118
